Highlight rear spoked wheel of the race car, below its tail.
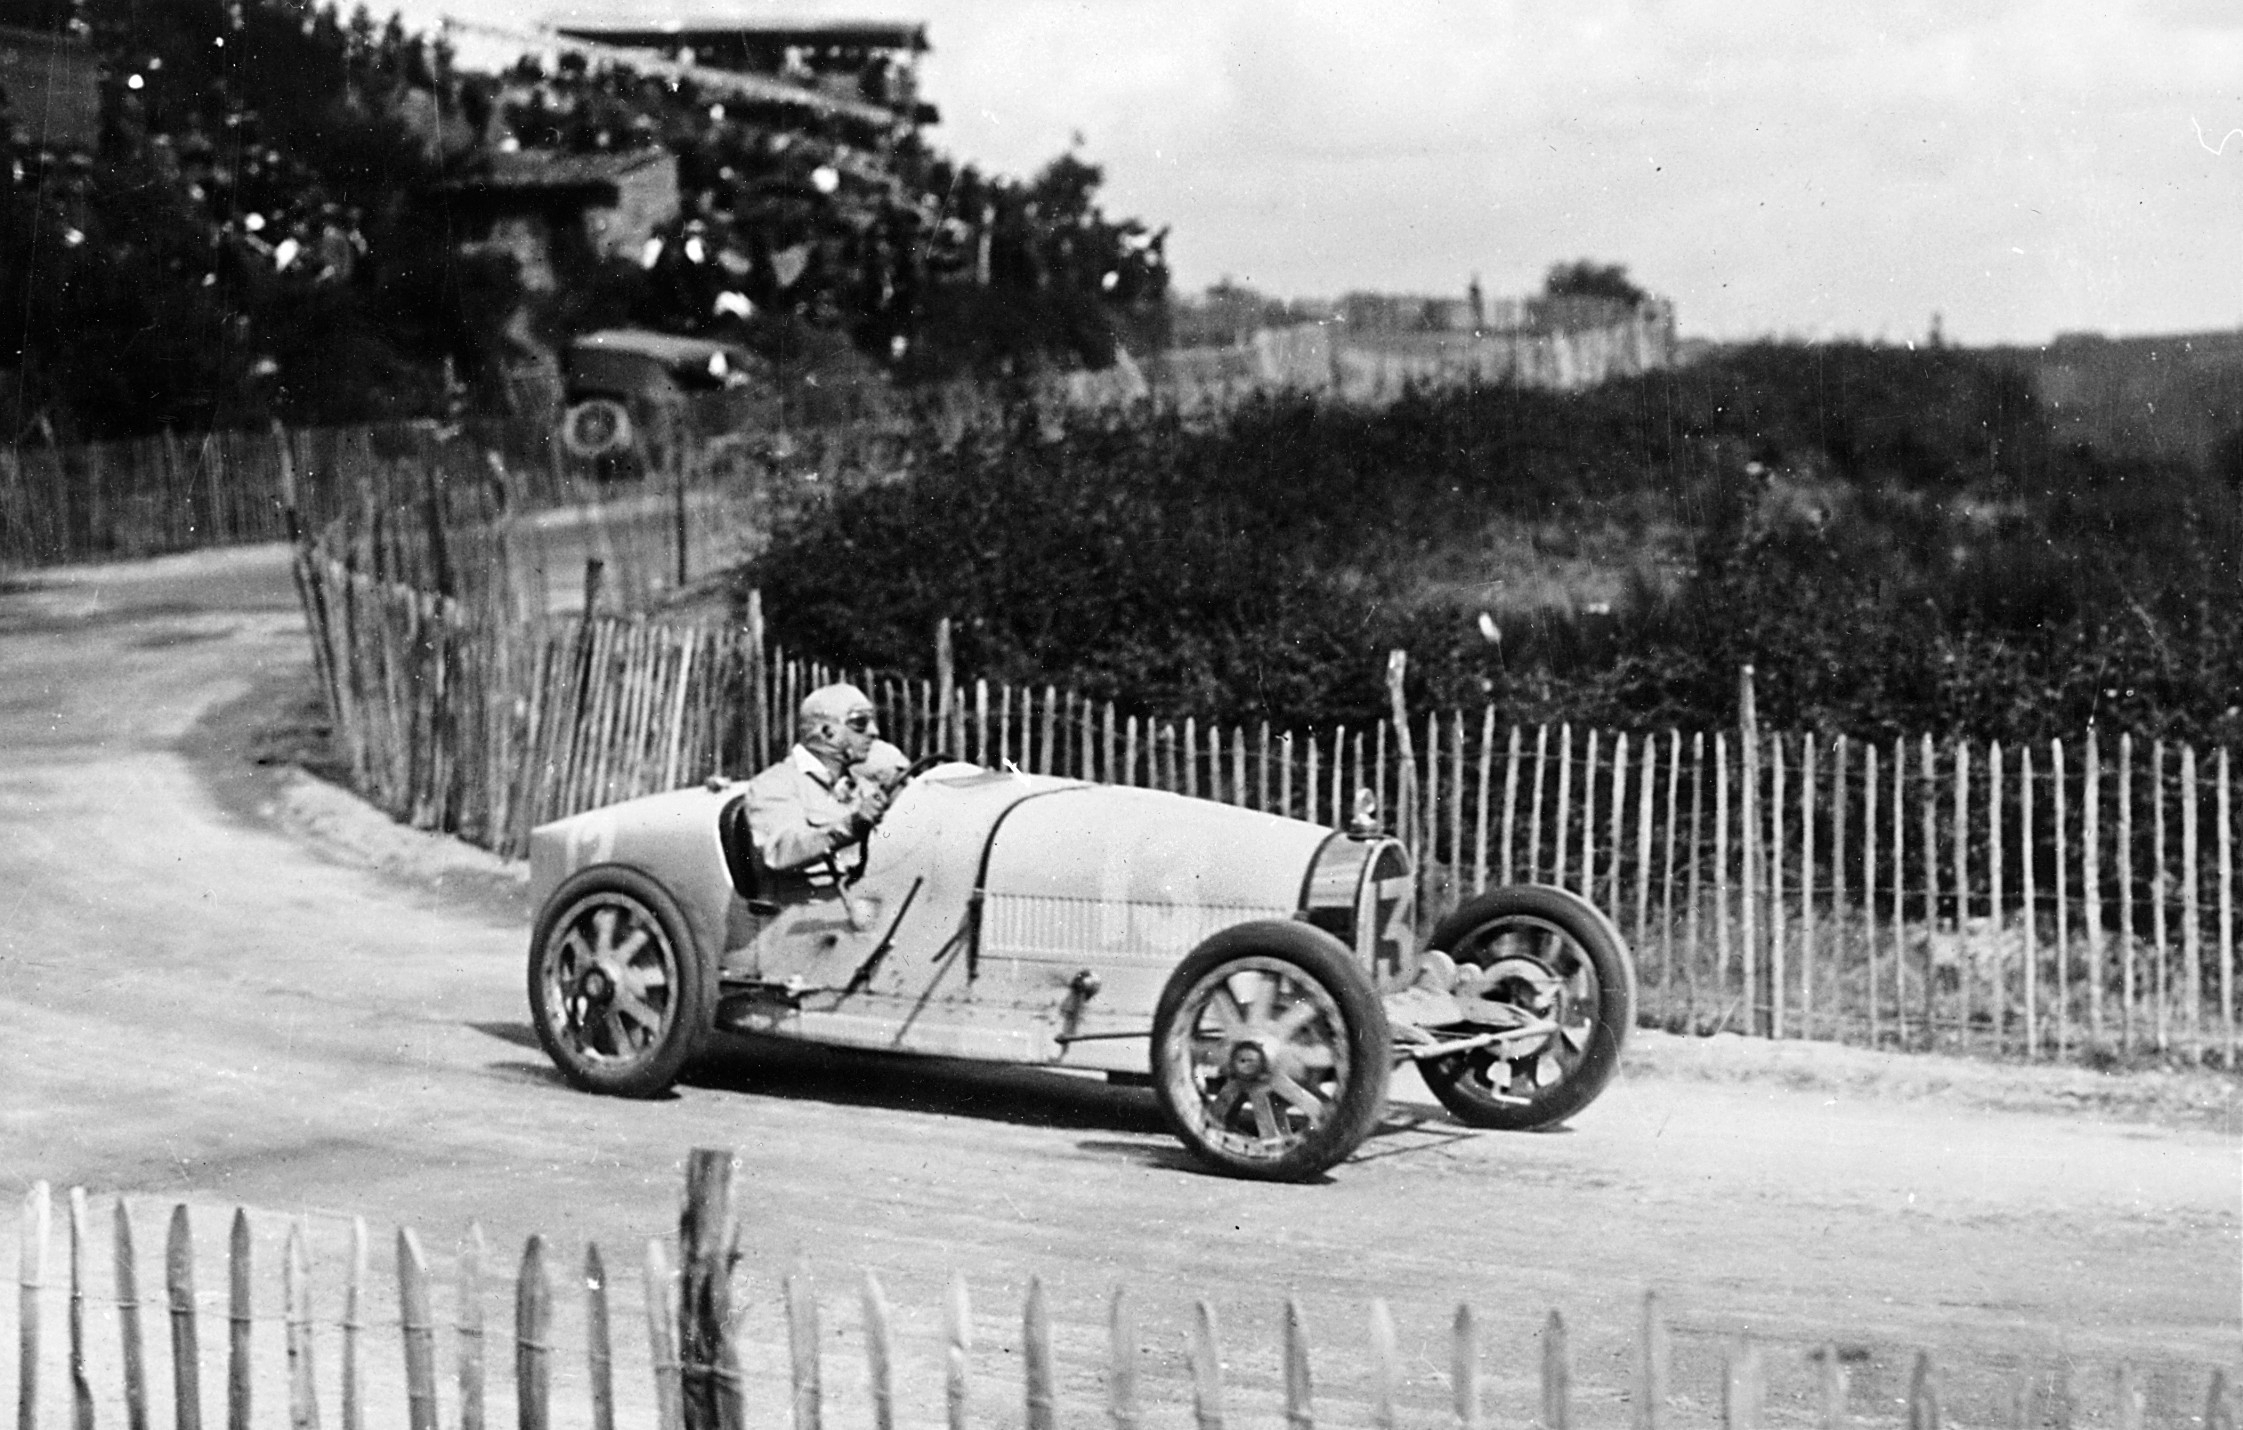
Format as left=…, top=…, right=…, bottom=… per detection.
left=529, top=865, right=716, bottom=1098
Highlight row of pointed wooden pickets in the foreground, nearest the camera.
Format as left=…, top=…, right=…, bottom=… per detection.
left=16, top=1150, right=2236, bottom=1430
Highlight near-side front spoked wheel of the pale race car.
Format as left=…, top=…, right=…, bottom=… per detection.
left=1153, top=919, right=1393, bottom=1181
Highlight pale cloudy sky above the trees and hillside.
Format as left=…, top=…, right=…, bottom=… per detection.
left=394, top=0, right=2243, bottom=345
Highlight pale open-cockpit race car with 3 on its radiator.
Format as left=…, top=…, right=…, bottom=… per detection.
left=529, top=762, right=1635, bottom=1179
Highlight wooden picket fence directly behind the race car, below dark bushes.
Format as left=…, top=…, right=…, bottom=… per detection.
left=298, top=504, right=2239, bottom=1067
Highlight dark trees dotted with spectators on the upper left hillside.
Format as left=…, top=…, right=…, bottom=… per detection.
left=0, top=0, right=1166, bottom=444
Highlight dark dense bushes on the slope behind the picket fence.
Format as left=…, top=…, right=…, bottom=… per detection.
left=742, top=343, right=2243, bottom=740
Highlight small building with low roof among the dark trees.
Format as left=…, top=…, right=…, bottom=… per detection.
left=442, top=148, right=680, bottom=291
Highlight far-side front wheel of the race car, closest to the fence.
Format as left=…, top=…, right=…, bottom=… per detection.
left=1418, top=885, right=1635, bottom=1132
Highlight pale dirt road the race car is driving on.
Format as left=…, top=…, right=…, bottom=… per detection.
left=0, top=549, right=2243, bottom=1426
